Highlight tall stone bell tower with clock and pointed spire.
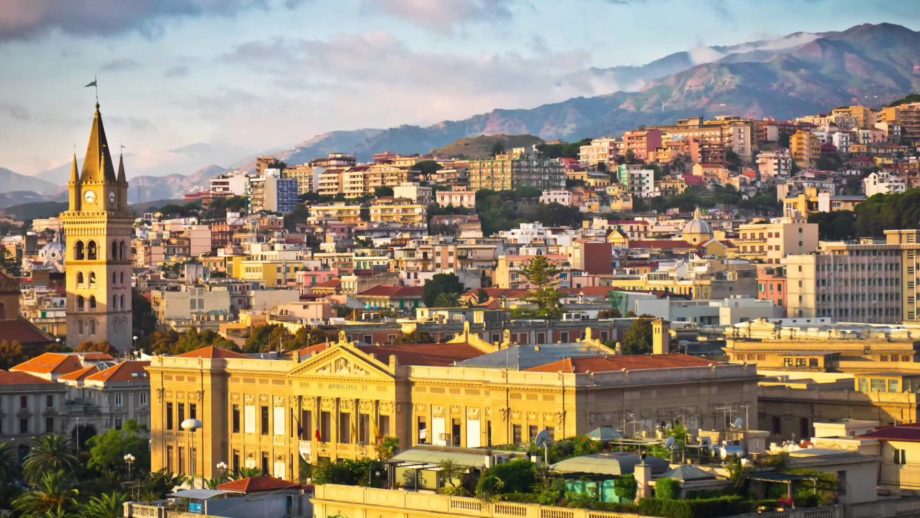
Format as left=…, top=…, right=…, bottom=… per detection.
left=61, top=102, right=134, bottom=351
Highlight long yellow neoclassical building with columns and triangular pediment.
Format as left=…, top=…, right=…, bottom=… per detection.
left=148, top=328, right=757, bottom=479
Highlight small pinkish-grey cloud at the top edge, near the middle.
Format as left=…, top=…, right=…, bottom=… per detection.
left=364, top=0, right=511, bottom=32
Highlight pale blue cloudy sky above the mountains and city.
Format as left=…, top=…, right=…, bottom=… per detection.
left=0, top=0, right=920, bottom=179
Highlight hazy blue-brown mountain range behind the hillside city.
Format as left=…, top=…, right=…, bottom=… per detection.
left=0, top=24, right=920, bottom=204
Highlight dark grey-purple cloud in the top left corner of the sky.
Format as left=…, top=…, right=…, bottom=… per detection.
left=0, top=0, right=300, bottom=42
